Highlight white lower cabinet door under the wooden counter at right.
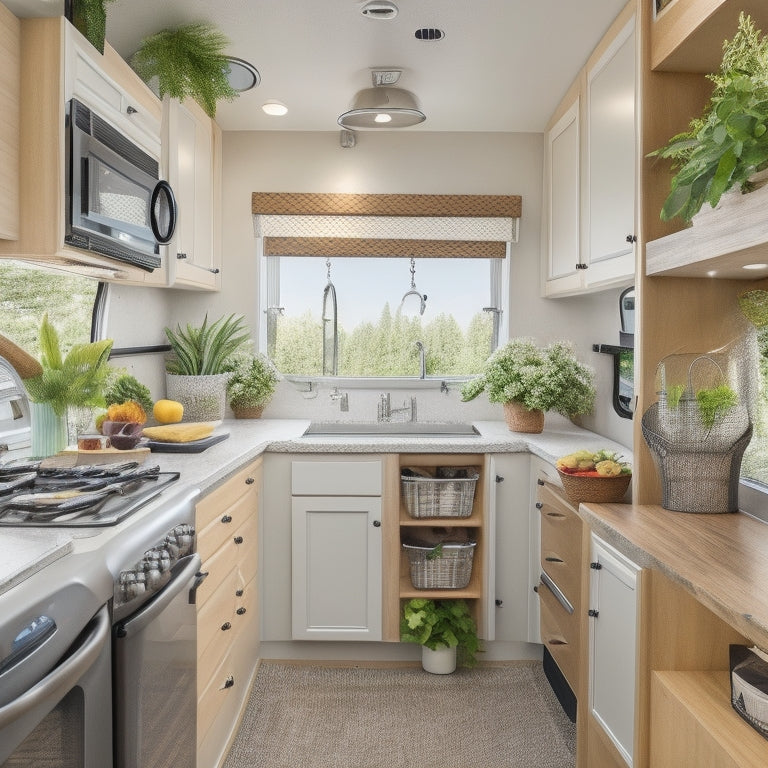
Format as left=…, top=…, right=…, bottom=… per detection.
left=589, top=534, right=640, bottom=766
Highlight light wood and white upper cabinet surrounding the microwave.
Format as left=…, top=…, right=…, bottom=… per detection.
left=0, top=17, right=167, bottom=285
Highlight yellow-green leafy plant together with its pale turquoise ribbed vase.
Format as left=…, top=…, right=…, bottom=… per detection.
left=23, top=314, right=112, bottom=457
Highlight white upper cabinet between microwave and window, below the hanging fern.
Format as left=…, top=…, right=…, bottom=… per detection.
left=163, top=97, right=221, bottom=290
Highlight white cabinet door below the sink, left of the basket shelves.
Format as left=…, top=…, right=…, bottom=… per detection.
left=291, top=496, right=382, bottom=640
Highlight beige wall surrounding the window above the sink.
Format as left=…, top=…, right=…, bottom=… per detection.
left=111, top=131, right=632, bottom=445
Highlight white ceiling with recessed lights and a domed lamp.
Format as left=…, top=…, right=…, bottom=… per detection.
left=7, top=0, right=626, bottom=132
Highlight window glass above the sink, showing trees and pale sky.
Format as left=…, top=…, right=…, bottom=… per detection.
left=266, top=257, right=501, bottom=377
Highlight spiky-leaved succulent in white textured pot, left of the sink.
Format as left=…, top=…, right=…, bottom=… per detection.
left=165, top=315, right=250, bottom=421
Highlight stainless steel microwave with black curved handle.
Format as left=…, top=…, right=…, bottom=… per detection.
left=64, top=99, right=177, bottom=272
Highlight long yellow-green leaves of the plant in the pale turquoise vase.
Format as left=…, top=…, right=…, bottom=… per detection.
left=24, top=314, right=112, bottom=416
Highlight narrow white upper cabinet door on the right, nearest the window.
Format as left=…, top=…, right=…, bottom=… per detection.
left=544, top=97, right=582, bottom=296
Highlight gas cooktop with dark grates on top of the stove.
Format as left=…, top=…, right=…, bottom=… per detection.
left=0, top=461, right=179, bottom=527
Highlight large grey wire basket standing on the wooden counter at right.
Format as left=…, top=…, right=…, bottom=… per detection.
left=641, top=355, right=752, bottom=513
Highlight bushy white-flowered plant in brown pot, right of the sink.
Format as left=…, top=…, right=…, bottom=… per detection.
left=461, top=338, right=595, bottom=433
